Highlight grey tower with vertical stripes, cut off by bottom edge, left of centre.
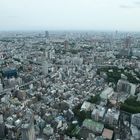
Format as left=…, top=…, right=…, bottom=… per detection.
left=21, top=111, right=36, bottom=140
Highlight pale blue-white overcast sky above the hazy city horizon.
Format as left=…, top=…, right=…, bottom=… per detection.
left=0, top=0, right=140, bottom=31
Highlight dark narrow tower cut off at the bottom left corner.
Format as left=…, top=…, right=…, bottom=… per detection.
left=0, top=114, right=5, bottom=139
